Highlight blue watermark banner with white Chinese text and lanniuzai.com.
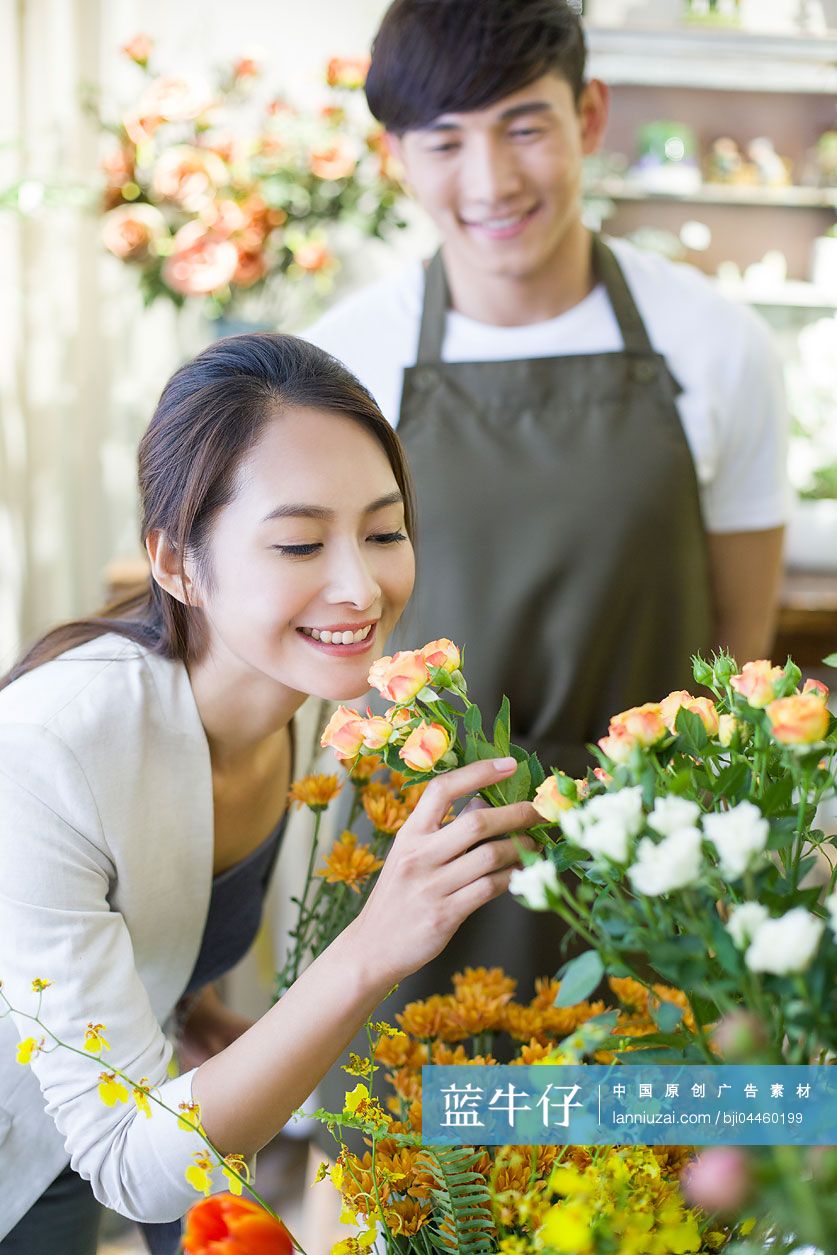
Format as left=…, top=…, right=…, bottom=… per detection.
left=422, top=1063, right=837, bottom=1146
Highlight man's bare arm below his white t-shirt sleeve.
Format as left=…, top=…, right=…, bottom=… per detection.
left=706, top=527, right=784, bottom=665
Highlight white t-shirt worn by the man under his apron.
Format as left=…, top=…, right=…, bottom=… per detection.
left=304, top=240, right=788, bottom=532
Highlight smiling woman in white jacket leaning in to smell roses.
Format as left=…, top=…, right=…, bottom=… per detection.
left=0, top=335, right=536, bottom=1255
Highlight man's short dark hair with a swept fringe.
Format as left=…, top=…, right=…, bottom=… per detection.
left=366, top=0, right=586, bottom=136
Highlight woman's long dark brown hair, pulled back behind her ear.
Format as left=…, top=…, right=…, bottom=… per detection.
left=0, top=333, right=415, bottom=688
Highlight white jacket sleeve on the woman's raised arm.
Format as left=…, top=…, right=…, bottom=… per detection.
left=0, top=724, right=220, bottom=1221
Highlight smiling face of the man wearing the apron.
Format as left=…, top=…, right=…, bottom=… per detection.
left=393, top=74, right=607, bottom=286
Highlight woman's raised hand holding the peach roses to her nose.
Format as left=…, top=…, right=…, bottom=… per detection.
left=344, top=758, right=542, bottom=988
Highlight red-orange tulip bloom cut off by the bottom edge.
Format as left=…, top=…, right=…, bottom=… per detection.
left=183, top=1194, right=294, bottom=1255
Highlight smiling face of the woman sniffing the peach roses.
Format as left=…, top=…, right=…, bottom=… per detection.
left=196, top=409, right=415, bottom=700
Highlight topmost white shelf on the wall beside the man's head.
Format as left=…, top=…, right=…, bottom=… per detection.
left=586, top=26, right=837, bottom=94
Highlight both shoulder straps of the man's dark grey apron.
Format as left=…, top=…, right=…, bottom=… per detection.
left=415, top=235, right=654, bottom=365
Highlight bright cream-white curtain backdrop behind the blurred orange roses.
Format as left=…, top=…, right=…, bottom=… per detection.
left=0, top=0, right=399, bottom=669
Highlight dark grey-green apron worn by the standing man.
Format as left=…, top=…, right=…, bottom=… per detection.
left=313, top=237, right=712, bottom=1139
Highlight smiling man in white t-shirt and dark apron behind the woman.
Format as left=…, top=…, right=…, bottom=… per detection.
left=302, top=0, right=786, bottom=1001
